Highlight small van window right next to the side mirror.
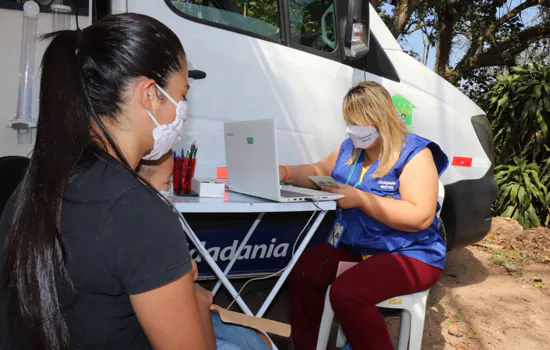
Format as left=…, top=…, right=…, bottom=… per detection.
left=288, top=0, right=338, bottom=52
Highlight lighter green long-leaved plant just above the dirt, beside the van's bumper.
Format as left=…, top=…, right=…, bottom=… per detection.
left=494, top=158, right=550, bottom=229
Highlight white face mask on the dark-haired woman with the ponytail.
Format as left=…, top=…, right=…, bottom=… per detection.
left=143, top=85, right=187, bottom=160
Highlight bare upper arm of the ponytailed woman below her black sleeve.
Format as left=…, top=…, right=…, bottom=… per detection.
left=130, top=272, right=216, bottom=350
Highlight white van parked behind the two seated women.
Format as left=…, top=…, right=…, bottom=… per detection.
left=1, top=0, right=497, bottom=254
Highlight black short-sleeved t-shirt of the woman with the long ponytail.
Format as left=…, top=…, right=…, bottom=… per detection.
left=0, top=155, right=191, bottom=349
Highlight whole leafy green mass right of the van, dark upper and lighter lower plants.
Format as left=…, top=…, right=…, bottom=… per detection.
left=488, top=64, right=550, bottom=228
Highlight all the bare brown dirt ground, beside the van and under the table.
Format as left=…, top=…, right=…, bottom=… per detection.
left=207, top=218, right=550, bottom=350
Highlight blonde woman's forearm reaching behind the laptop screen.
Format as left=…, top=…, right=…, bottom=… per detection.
left=279, top=148, right=340, bottom=188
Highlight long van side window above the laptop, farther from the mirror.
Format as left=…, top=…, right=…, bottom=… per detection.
left=167, top=0, right=281, bottom=41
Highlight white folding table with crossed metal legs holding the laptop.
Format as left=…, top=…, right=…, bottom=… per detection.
left=172, top=191, right=336, bottom=317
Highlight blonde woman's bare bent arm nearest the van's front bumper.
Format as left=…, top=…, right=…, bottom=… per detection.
left=324, top=148, right=439, bottom=232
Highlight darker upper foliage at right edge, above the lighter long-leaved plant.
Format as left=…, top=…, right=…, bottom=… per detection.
left=481, top=64, right=550, bottom=167
